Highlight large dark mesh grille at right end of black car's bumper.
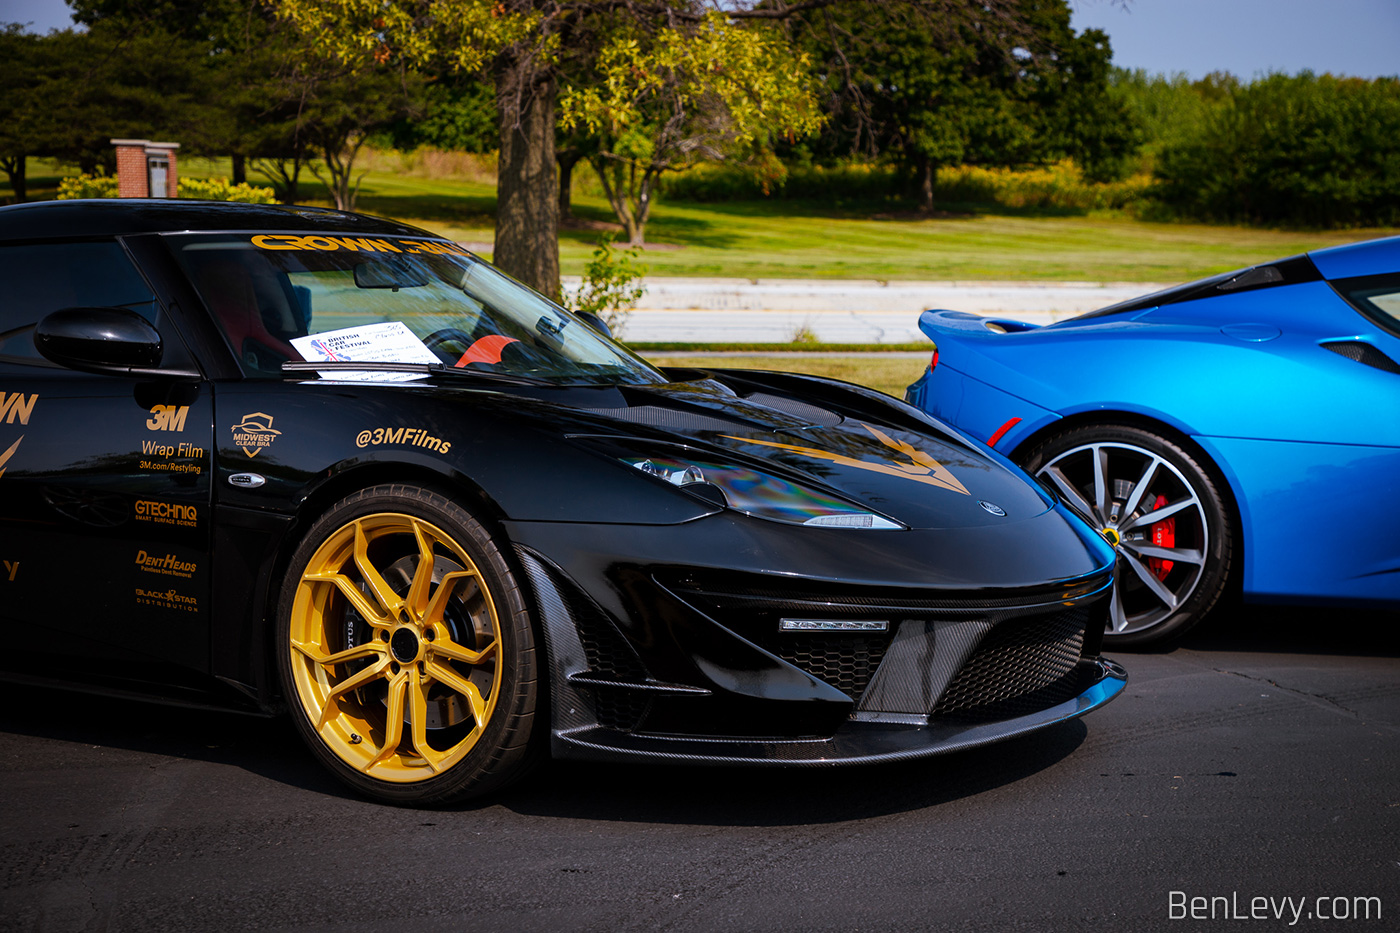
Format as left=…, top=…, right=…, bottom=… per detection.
left=934, top=607, right=1089, bottom=720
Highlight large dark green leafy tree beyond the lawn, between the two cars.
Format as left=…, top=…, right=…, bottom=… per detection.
left=794, top=0, right=1137, bottom=210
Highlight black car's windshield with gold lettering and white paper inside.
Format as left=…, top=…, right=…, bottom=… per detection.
left=168, top=234, right=665, bottom=385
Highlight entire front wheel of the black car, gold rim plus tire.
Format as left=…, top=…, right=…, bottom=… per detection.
left=277, top=485, right=539, bottom=806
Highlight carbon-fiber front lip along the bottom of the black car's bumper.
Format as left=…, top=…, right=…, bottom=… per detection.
left=553, top=658, right=1128, bottom=768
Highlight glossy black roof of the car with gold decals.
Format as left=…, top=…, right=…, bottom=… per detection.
left=0, top=198, right=434, bottom=242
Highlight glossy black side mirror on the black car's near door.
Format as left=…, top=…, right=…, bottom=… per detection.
left=34, top=308, right=161, bottom=373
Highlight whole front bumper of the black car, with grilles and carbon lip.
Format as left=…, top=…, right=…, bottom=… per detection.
left=511, top=517, right=1124, bottom=765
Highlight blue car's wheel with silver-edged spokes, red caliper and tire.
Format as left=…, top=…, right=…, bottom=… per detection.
left=1016, top=424, right=1235, bottom=649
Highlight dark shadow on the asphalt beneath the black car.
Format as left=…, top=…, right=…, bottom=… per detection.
left=0, top=672, right=1086, bottom=827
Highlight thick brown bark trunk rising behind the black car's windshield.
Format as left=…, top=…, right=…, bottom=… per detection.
left=491, top=62, right=560, bottom=298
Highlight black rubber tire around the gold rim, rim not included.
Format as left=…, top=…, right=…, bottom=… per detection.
left=276, top=485, right=538, bottom=806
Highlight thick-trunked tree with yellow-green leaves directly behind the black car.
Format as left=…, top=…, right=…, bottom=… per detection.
left=277, top=0, right=1009, bottom=296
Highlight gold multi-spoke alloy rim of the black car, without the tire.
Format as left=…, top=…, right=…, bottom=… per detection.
left=287, top=511, right=505, bottom=785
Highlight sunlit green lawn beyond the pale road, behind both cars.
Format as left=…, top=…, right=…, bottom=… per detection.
left=8, top=158, right=1400, bottom=283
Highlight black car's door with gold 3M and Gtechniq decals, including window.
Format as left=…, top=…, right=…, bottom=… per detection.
left=0, top=240, right=213, bottom=684
